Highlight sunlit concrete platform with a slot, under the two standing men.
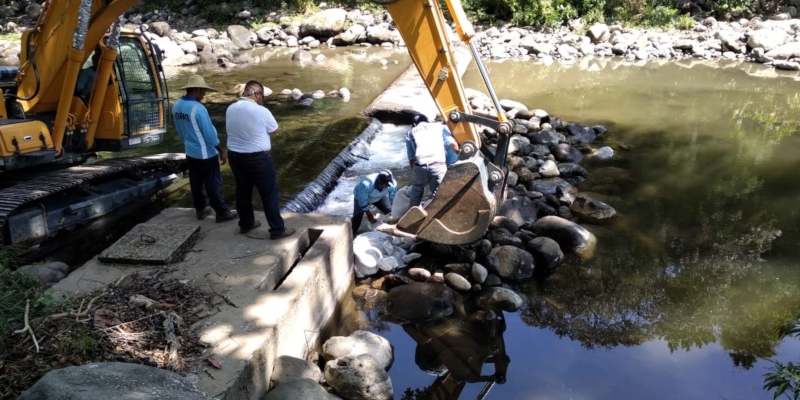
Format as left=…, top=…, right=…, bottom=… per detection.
left=54, top=208, right=353, bottom=399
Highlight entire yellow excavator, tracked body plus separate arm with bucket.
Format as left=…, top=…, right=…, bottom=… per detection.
left=0, top=0, right=506, bottom=248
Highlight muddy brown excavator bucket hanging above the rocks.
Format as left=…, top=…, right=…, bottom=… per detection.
left=397, top=142, right=504, bottom=244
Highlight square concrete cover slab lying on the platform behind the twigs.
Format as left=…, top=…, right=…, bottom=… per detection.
left=97, top=223, right=200, bottom=265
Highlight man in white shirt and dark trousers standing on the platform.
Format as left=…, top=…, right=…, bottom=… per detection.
left=225, top=81, right=295, bottom=240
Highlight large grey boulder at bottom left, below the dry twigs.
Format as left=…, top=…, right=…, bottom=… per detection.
left=17, top=362, right=211, bottom=400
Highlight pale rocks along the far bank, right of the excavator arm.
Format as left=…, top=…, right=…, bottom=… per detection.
left=478, top=16, right=800, bottom=70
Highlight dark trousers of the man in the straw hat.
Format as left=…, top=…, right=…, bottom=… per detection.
left=186, top=156, right=228, bottom=215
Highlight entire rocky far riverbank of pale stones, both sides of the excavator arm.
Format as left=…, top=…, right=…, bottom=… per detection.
left=0, top=8, right=800, bottom=71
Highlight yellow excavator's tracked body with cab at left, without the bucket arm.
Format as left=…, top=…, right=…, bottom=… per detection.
left=0, top=0, right=185, bottom=245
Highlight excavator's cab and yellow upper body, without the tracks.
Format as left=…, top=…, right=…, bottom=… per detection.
left=0, top=12, right=169, bottom=171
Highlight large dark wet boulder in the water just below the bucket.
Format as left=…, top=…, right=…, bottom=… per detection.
left=389, top=282, right=455, bottom=323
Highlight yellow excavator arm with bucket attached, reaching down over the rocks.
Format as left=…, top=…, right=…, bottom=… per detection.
left=373, top=0, right=515, bottom=244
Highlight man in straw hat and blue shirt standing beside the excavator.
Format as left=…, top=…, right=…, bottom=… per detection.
left=172, top=75, right=237, bottom=222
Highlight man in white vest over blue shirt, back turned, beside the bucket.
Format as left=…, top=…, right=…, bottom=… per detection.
left=406, top=114, right=459, bottom=207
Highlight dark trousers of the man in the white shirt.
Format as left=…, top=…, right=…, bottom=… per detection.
left=228, top=151, right=285, bottom=236
